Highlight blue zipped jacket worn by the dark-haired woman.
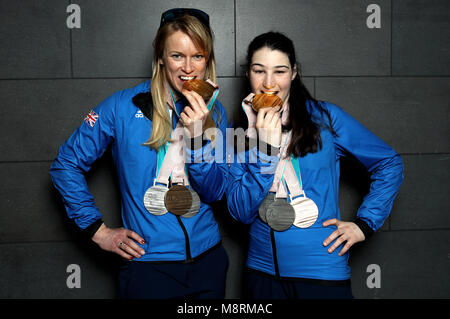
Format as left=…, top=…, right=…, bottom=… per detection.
left=226, top=101, right=403, bottom=280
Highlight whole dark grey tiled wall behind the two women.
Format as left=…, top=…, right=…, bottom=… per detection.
left=0, top=0, right=450, bottom=298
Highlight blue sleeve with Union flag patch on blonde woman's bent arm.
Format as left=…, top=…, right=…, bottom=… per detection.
left=50, top=96, right=116, bottom=230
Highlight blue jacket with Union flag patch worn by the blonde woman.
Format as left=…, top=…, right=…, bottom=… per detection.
left=50, top=81, right=228, bottom=261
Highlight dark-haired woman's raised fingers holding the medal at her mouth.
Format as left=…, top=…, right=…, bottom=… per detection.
left=256, top=106, right=281, bottom=147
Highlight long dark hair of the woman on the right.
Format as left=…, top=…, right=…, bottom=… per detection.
left=239, top=32, right=335, bottom=157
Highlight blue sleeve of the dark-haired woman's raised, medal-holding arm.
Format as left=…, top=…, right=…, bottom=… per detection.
left=226, top=143, right=279, bottom=224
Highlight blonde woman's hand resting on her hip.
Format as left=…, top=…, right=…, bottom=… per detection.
left=92, top=224, right=145, bottom=260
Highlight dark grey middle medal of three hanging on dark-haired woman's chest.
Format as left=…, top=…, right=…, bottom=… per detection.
left=266, top=198, right=295, bottom=231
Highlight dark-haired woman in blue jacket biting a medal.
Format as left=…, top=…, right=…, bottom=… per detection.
left=227, top=32, right=403, bottom=298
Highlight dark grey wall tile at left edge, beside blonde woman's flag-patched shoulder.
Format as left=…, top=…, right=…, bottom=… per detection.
left=0, top=79, right=143, bottom=161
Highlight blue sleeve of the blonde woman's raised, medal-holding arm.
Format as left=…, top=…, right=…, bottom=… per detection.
left=186, top=102, right=228, bottom=203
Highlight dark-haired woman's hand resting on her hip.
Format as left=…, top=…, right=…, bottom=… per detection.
left=322, top=218, right=366, bottom=256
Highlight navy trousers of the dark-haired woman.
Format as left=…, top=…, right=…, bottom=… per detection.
left=247, top=270, right=353, bottom=299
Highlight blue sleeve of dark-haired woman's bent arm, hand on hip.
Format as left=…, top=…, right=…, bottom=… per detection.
left=327, top=103, right=403, bottom=237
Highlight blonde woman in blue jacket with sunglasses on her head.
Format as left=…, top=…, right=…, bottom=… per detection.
left=50, top=9, right=228, bottom=298
